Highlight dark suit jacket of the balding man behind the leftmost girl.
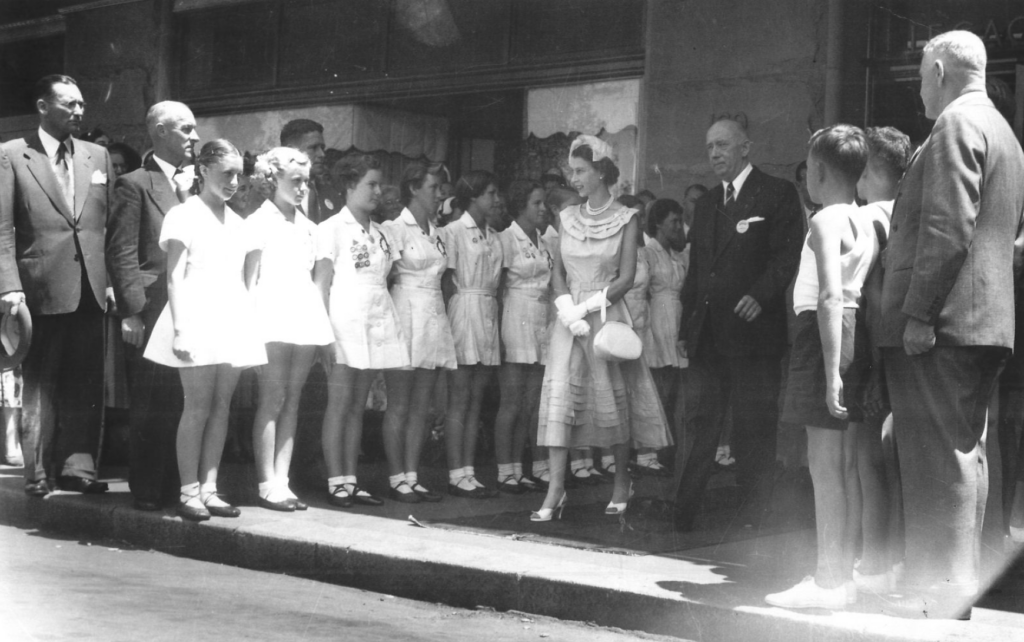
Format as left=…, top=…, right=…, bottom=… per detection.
left=106, top=156, right=178, bottom=317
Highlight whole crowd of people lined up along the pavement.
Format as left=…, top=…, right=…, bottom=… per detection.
left=0, top=32, right=1024, bottom=616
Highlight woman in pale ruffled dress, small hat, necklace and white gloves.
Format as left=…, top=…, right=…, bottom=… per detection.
left=530, top=135, right=672, bottom=521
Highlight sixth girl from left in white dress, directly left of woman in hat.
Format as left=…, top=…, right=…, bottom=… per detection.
left=495, top=180, right=554, bottom=495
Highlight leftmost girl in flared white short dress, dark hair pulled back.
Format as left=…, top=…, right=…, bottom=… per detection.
left=144, top=139, right=266, bottom=521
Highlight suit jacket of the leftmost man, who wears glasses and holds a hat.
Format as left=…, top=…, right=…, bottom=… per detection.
left=0, top=133, right=114, bottom=314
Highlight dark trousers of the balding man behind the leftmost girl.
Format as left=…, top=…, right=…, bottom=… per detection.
left=125, top=302, right=183, bottom=503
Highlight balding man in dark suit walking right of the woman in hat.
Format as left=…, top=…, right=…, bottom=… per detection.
left=675, top=115, right=802, bottom=530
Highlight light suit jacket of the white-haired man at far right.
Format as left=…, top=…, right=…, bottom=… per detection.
left=880, top=91, right=1024, bottom=348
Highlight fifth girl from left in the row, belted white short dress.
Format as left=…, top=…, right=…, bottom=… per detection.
left=443, top=170, right=502, bottom=499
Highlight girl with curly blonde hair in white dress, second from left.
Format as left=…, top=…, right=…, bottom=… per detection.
left=245, top=147, right=334, bottom=511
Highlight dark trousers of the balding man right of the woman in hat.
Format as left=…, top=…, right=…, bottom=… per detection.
left=674, top=347, right=780, bottom=529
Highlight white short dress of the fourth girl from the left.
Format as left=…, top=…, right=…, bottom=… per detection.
left=382, top=209, right=456, bottom=370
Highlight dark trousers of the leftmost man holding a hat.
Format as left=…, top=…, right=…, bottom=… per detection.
left=22, top=296, right=103, bottom=481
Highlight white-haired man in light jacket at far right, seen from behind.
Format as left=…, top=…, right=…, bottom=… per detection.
left=880, top=32, right=1024, bottom=617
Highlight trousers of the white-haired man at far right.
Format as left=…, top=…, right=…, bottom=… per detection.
left=883, top=346, right=1010, bottom=595
